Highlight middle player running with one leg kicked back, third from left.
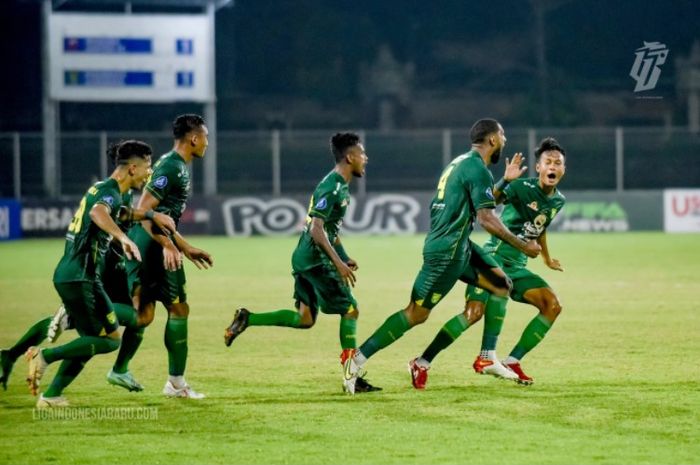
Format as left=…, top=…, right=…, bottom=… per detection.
left=224, top=132, right=379, bottom=392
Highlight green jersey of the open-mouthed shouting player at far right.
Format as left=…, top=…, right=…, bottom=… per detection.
left=484, top=178, right=566, bottom=266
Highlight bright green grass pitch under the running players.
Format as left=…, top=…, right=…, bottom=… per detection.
left=0, top=233, right=700, bottom=464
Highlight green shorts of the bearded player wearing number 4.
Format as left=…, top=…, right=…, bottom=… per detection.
left=411, top=241, right=498, bottom=310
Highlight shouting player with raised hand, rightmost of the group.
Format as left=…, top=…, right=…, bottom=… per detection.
left=409, top=138, right=566, bottom=389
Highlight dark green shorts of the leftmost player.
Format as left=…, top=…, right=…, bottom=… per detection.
left=53, top=280, right=119, bottom=336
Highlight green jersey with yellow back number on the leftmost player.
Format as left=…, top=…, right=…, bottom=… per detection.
left=53, top=178, right=122, bottom=283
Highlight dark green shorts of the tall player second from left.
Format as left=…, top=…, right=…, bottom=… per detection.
left=126, top=224, right=187, bottom=305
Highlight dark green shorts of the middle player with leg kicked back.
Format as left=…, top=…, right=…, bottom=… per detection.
left=292, top=263, right=357, bottom=317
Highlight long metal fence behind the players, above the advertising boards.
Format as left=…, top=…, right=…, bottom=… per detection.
left=0, top=127, right=700, bottom=199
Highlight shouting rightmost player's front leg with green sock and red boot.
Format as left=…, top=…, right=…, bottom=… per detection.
left=503, top=273, right=562, bottom=384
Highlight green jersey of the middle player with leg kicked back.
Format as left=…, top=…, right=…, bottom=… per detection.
left=292, top=171, right=350, bottom=271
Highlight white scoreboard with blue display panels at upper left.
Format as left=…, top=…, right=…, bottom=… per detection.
left=48, top=13, right=214, bottom=102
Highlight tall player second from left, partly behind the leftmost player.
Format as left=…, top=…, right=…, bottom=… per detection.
left=107, top=114, right=213, bottom=399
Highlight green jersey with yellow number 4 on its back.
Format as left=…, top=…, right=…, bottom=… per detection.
left=423, top=150, right=496, bottom=260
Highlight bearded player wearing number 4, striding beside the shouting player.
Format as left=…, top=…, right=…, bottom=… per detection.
left=344, top=119, right=540, bottom=394
